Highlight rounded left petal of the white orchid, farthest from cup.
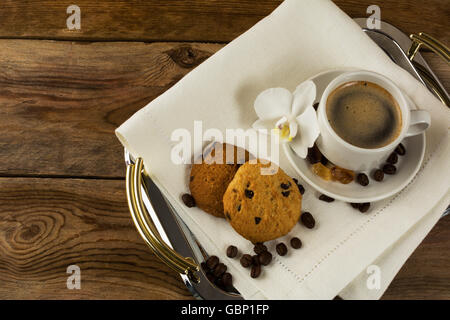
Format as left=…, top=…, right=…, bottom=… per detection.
left=254, top=88, right=292, bottom=120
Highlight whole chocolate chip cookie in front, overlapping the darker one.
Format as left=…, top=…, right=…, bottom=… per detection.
left=223, top=162, right=302, bottom=243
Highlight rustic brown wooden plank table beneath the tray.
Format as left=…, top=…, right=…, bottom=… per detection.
left=0, top=0, right=450, bottom=299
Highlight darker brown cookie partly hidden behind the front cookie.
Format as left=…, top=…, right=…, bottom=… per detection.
left=189, top=143, right=249, bottom=218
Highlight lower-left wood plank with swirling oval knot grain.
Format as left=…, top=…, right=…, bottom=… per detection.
left=0, top=178, right=192, bottom=300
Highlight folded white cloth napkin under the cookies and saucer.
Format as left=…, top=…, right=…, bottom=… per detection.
left=116, top=0, right=450, bottom=299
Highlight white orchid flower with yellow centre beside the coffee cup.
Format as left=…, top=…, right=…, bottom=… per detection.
left=253, top=81, right=320, bottom=159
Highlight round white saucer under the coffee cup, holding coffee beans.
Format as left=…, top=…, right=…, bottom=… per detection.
left=283, top=70, right=425, bottom=203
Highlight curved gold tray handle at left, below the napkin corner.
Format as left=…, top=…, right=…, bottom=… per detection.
left=126, top=158, right=199, bottom=283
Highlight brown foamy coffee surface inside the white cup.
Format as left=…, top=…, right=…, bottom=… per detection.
left=326, top=81, right=402, bottom=149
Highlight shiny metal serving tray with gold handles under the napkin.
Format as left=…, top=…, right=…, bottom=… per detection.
left=125, top=18, right=450, bottom=300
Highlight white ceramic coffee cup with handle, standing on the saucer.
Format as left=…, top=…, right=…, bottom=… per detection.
left=317, top=71, right=431, bottom=171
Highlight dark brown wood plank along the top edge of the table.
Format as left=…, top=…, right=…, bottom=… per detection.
left=0, top=0, right=450, bottom=43
